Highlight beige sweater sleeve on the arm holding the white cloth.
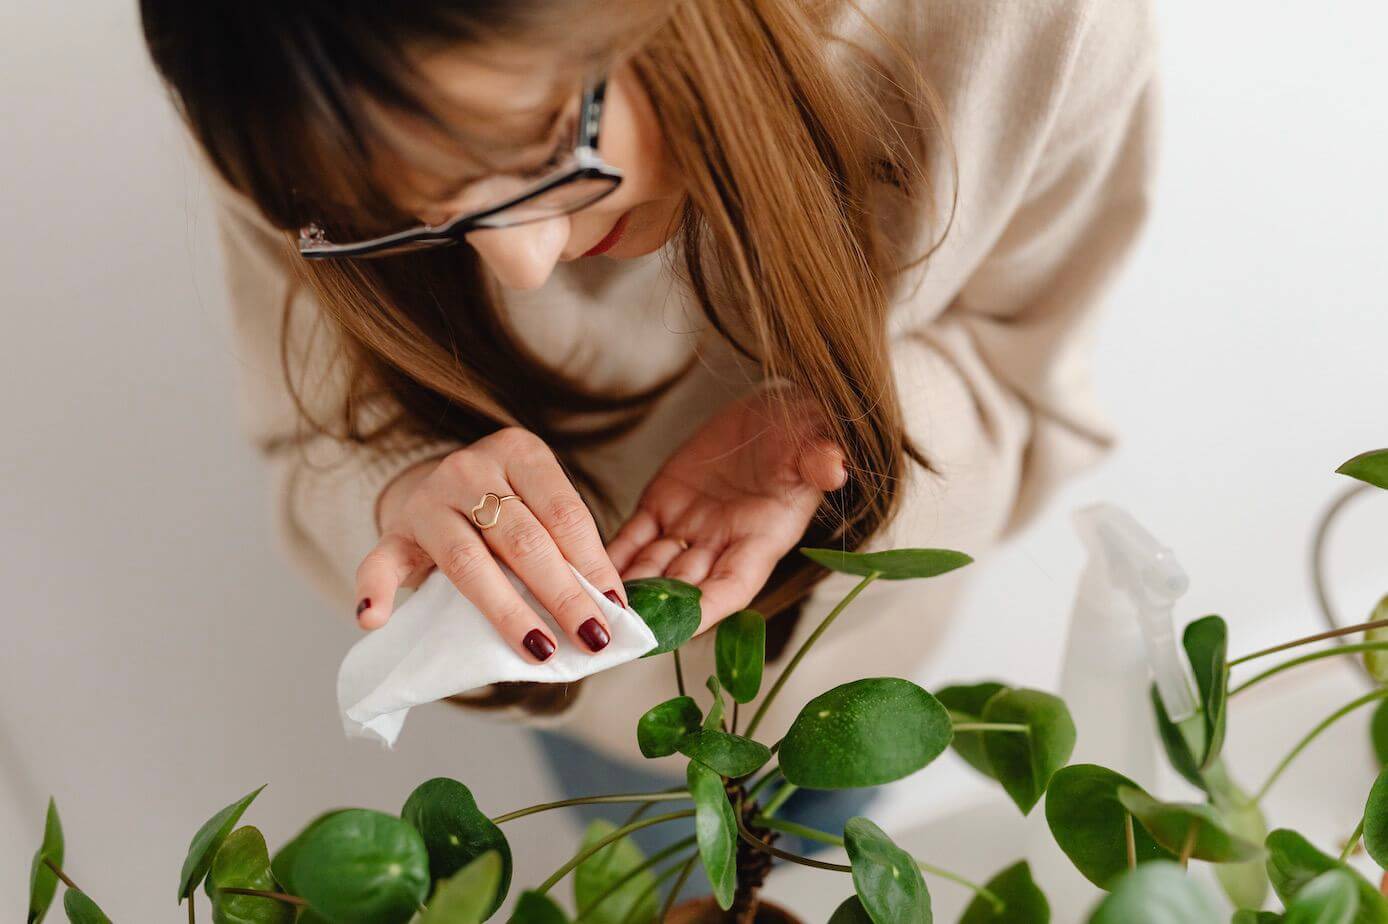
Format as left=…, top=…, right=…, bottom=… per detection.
left=205, top=169, right=461, bottom=612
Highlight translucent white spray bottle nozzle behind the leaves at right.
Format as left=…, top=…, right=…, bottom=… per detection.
left=1074, top=504, right=1196, bottom=721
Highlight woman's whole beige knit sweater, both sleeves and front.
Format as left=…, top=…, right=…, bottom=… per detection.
left=212, top=0, right=1160, bottom=760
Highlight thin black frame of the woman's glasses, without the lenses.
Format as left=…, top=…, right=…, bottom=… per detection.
left=298, top=75, right=623, bottom=259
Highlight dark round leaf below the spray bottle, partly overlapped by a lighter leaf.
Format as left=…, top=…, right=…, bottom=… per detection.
left=1045, top=763, right=1176, bottom=889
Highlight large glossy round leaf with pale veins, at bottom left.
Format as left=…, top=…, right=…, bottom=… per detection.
left=293, top=809, right=429, bottom=924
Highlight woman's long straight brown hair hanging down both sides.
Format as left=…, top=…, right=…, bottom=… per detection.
left=142, top=0, right=954, bottom=615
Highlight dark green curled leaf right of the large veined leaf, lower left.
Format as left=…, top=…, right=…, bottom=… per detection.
left=400, top=777, right=511, bottom=920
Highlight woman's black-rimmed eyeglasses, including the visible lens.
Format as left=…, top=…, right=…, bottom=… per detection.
left=298, top=70, right=622, bottom=259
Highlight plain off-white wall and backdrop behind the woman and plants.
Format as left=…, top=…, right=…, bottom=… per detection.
left=0, top=0, right=1388, bottom=921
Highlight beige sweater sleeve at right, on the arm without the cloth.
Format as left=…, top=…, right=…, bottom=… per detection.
left=873, top=0, right=1160, bottom=551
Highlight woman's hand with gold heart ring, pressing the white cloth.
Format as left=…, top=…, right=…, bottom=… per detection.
left=357, top=427, right=626, bottom=660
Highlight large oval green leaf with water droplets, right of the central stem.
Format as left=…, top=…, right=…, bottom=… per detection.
left=780, top=677, right=954, bottom=789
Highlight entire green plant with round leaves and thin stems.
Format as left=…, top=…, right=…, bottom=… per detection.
left=18, top=451, right=1388, bottom=924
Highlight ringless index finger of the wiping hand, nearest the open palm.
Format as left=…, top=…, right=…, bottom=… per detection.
left=507, top=455, right=626, bottom=606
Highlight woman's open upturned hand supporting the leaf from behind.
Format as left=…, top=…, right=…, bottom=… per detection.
left=608, top=391, right=848, bottom=631
